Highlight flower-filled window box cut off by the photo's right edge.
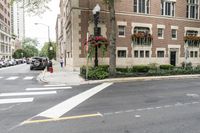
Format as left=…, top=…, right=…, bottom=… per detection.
left=184, top=35, right=200, bottom=47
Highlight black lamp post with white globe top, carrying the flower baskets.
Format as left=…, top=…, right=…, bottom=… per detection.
left=92, top=4, right=101, bottom=67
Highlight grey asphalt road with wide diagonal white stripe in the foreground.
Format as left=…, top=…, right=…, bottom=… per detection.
left=0, top=66, right=200, bottom=133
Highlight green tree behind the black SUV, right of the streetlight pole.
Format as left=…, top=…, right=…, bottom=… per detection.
left=39, top=42, right=57, bottom=59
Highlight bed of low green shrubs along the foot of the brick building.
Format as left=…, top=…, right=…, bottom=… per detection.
left=80, top=64, right=200, bottom=80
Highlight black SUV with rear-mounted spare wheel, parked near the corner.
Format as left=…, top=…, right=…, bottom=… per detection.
left=30, top=57, right=48, bottom=70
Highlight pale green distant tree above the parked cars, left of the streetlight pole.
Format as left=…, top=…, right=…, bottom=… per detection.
left=22, top=38, right=39, bottom=57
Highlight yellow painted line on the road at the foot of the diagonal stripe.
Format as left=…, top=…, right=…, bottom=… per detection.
left=21, top=113, right=103, bottom=125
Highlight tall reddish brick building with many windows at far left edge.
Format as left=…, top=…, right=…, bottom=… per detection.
left=0, top=0, right=12, bottom=59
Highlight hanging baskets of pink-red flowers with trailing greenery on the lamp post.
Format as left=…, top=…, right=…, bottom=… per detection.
left=83, top=35, right=109, bottom=58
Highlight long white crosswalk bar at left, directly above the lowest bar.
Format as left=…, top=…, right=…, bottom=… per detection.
left=0, top=91, right=57, bottom=97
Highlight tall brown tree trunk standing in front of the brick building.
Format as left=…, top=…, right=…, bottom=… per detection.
left=109, top=0, right=116, bottom=77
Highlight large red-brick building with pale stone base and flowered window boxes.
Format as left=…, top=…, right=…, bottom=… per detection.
left=55, top=0, right=200, bottom=68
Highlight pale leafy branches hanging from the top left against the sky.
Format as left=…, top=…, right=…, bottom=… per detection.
left=11, top=0, right=51, bottom=15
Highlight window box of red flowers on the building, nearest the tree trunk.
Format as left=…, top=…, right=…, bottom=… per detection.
left=132, top=32, right=153, bottom=45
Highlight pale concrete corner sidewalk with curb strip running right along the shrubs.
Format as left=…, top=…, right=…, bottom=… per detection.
left=37, top=61, right=200, bottom=85
